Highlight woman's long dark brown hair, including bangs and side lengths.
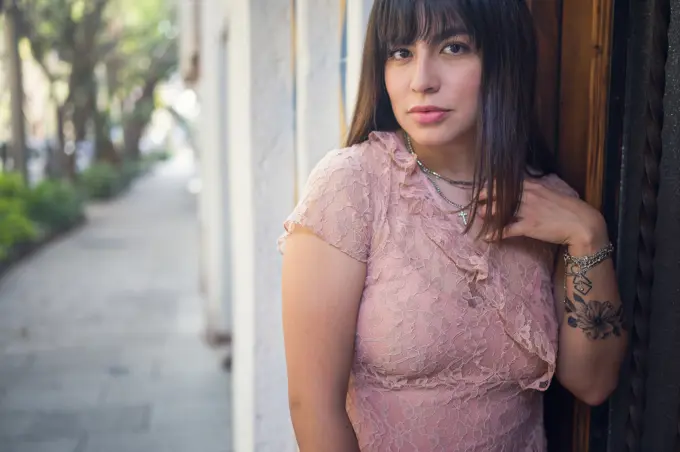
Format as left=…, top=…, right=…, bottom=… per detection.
left=346, top=0, right=555, bottom=238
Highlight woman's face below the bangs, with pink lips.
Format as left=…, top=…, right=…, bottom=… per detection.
left=385, top=32, right=482, bottom=147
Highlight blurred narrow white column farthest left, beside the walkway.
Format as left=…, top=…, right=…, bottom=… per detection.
left=198, top=0, right=231, bottom=338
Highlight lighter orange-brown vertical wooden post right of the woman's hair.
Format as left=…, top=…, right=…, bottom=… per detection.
left=557, top=0, right=615, bottom=452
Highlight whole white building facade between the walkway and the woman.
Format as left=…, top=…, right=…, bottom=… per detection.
left=178, top=0, right=372, bottom=452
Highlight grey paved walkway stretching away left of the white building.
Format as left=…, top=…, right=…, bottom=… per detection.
left=0, top=153, right=231, bottom=452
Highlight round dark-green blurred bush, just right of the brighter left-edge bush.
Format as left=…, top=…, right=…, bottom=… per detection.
left=27, top=180, right=84, bottom=231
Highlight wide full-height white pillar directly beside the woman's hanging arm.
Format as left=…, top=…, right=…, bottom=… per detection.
left=227, top=0, right=297, bottom=452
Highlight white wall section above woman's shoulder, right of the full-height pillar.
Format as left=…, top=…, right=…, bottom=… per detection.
left=295, top=0, right=344, bottom=193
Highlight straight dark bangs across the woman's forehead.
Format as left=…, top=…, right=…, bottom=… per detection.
left=376, top=0, right=476, bottom=54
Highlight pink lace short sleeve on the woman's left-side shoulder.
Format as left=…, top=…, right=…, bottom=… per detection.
left=278, top=148, right=373, bottom=262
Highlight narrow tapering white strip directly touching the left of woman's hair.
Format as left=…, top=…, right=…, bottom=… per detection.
left=345, top=0, right=373, bottom=124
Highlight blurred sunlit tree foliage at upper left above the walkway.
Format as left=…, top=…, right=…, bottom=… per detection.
left=16, top=0, right=178, bottom=162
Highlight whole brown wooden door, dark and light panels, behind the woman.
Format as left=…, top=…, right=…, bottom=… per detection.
left=528, top=0, right=628, bottom=452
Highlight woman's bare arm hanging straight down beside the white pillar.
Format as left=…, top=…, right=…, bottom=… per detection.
left=282, top=227, right=366, bottom=452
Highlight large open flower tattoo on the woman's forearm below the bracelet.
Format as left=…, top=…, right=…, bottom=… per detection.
left=565, top=293, right=625, bottom=340
